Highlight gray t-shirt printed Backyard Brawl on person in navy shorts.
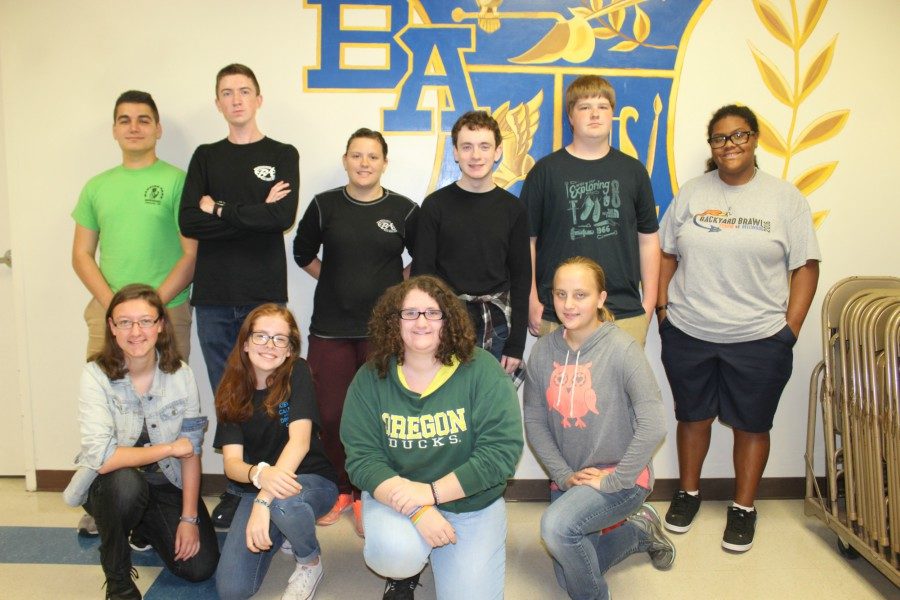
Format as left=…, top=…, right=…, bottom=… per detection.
left=660, top=171, right=821, bottom=343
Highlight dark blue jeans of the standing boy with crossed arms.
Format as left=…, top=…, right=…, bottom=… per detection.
left=194, top=304, right=260, bottom=396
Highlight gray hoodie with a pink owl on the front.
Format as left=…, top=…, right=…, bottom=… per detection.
left=524, top=323, right=666, bottom=492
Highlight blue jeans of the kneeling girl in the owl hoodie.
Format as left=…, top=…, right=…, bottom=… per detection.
left=541, top=485, right=650, bottom=600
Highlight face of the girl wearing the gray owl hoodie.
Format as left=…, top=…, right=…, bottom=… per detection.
left=553, top=265, right=606, bottom=336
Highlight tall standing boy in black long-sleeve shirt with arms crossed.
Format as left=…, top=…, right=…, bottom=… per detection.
left=179, top=64, right=300, bottom=527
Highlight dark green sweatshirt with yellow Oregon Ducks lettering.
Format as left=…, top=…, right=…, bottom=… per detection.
left=341, top=348, right=523, bottom=513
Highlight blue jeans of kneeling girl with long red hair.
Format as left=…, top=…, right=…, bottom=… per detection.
left=216, top=475, right=337, bottom=600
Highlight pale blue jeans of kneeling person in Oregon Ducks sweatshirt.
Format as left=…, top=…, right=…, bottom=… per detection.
left=364, top=492, right=506, bottom=600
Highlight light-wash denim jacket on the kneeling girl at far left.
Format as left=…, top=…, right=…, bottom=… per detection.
left=63, top=362, right=207, bottom=506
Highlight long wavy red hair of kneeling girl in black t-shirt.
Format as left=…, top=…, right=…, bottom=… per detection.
left=216, top=303, right=300, bottom=423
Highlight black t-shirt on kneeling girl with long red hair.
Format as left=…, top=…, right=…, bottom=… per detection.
left=213, top=358, right=337, bottom=492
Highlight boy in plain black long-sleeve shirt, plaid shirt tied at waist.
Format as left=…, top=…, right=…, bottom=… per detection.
left=412, top=111, right=531, bottom=374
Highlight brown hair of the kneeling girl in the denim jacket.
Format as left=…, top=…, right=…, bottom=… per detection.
left=88, top=283, right=181, bottom=381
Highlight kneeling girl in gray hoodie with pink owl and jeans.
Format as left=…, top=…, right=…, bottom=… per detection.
left=525, top=257, right=675, bottom=600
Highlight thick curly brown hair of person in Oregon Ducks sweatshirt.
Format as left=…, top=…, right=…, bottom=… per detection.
left=369, top=275, right=475, bottom=378
